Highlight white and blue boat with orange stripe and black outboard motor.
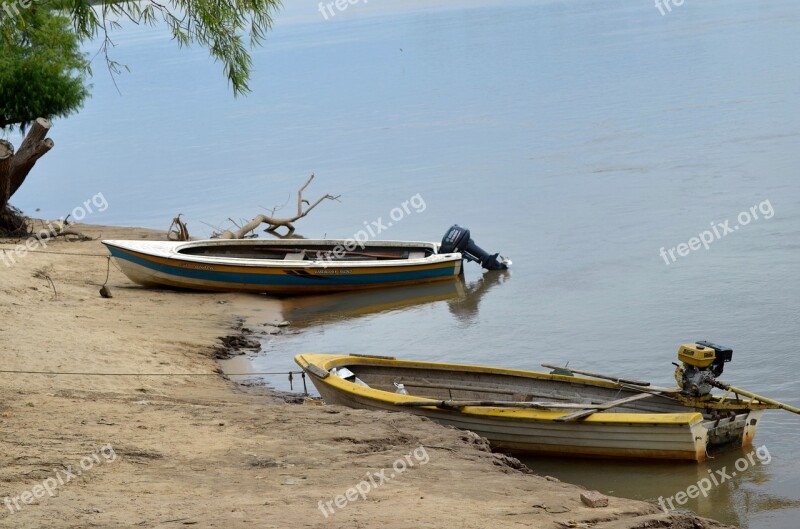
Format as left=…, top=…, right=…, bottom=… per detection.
left=103, top=226, right=510, bottom=295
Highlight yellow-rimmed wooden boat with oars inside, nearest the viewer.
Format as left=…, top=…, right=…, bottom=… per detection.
left=295, top=354, right=770, bottom=461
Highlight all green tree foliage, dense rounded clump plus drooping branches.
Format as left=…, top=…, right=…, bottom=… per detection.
left=0, top=0, right=281, bottom=129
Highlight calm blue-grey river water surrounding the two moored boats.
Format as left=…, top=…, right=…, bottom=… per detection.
left=16, top=0, right=800, bottom=529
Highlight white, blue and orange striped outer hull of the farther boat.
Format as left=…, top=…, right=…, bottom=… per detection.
left=104, top=241, right=462, bottom=295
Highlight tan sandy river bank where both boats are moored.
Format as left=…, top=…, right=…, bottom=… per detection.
left=0, top=226, right=736, bottom=529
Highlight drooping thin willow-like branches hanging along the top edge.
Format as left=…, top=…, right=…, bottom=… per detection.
left=69, top=0, right=281, bottom=95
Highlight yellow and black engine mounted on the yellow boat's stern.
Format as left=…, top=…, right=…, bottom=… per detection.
left=675, top=341, right=733, bottom=396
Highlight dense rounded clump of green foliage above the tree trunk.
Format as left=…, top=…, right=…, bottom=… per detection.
left=0, top=4, right=89, bottom=129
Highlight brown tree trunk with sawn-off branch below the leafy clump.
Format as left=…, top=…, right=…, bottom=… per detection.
left=0, top=118, right=53, bottom=233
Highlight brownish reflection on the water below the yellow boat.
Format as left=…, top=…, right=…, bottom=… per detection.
left=522, top=447, right=800, bottom=529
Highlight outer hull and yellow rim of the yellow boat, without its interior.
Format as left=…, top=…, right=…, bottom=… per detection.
left=296, top=355, right=762, bottom=461
